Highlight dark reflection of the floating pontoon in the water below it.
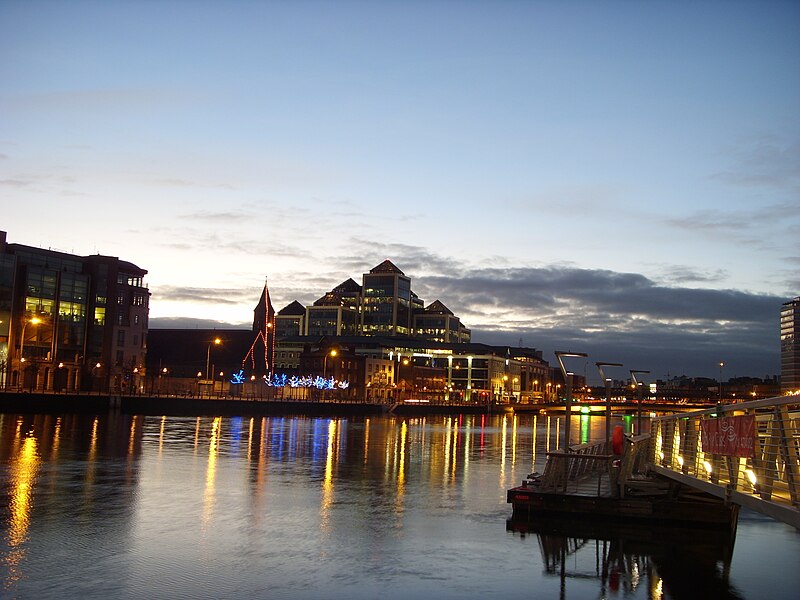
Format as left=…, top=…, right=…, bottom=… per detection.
left=506, top=516, right=742, bottom=600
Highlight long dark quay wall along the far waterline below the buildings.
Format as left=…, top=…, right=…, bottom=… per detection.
left=0, top=392, right=486, bottom=417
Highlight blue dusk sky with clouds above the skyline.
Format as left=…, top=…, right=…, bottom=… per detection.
left=0, top=0, right=800, bottom=379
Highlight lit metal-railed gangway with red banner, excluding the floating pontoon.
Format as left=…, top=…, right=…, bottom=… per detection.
left=649, top=396, right=800, bottom=528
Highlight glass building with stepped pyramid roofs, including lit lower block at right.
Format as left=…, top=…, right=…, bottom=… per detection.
left=274, top=260, right=550, bottom=403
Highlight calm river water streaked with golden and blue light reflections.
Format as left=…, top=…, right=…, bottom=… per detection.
left=0, top=414, right=800, bottom=600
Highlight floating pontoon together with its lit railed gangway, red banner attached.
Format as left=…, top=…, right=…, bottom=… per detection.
left=508, top=396, right=800, bottom=530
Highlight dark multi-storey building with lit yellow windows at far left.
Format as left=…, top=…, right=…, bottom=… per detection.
left=0, top=231, right=150, bottom=392
